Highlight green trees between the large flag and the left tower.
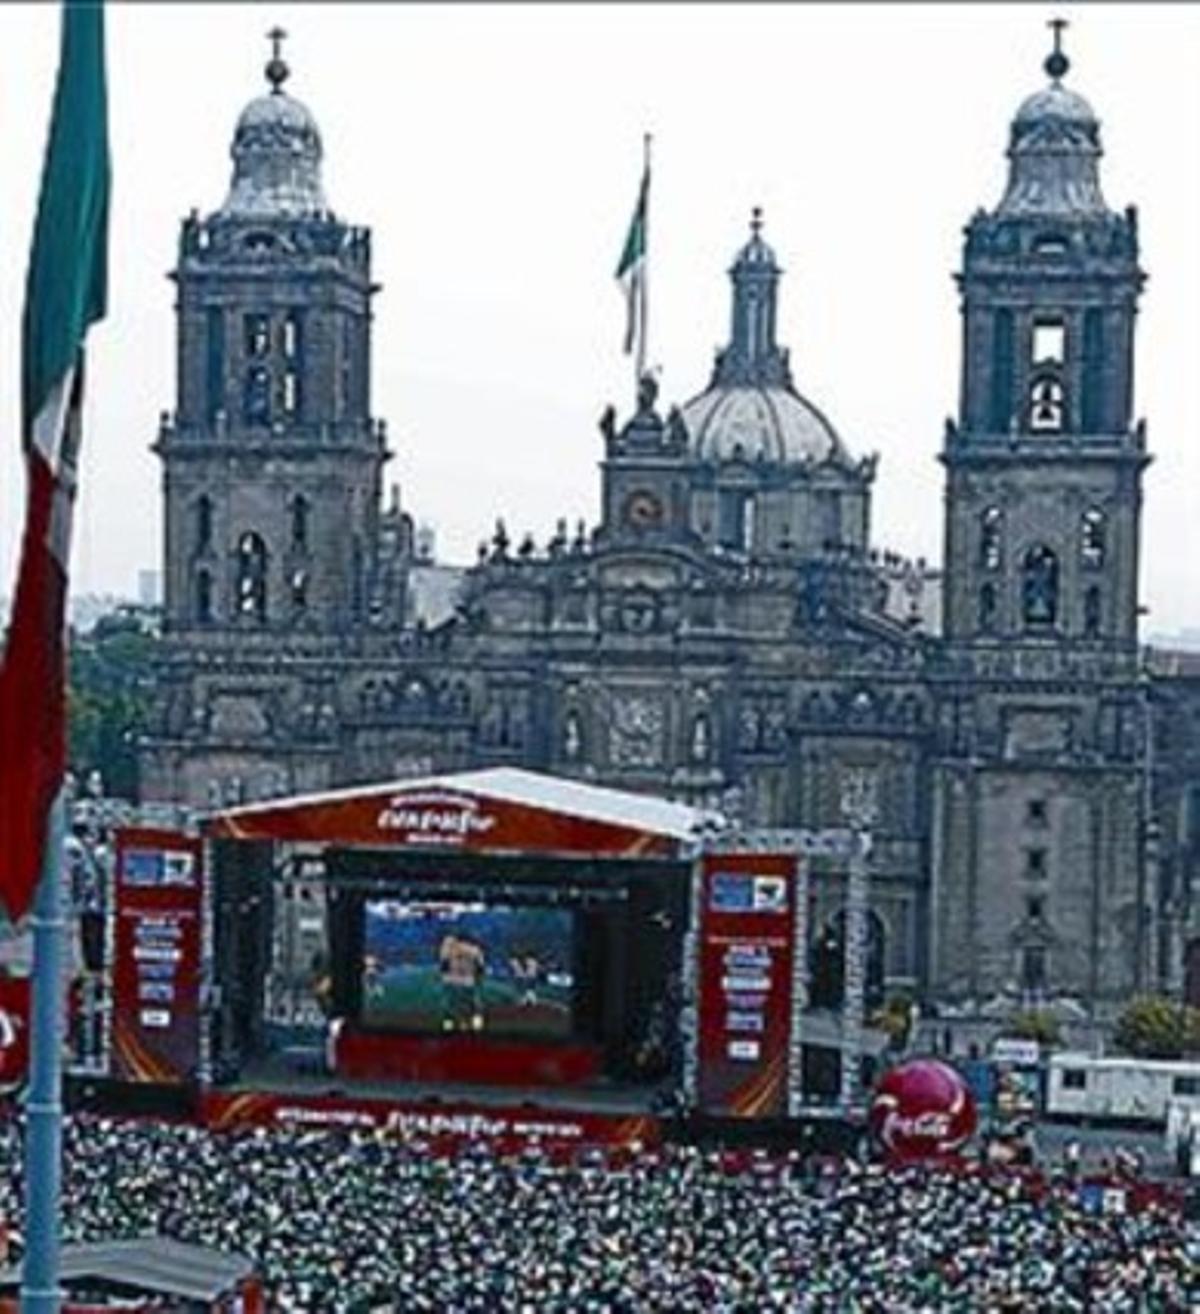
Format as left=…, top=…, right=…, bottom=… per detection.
left=67, top=607, right=158, bottom=799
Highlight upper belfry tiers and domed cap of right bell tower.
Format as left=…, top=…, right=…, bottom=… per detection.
left=942, top=20, right=1149, bottom=653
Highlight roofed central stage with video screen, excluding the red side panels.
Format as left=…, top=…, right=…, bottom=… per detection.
left=157, top=770, right=703, bottom=1144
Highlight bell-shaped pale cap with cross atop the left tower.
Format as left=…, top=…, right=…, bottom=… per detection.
left=221, top=33, right=329, bottom=219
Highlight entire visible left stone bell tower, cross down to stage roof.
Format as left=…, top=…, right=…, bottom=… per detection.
left=142, top=29, right=394, bottom=803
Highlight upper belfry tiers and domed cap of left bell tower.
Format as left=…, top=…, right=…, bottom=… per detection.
left=156, top=32, right=386, bottom=641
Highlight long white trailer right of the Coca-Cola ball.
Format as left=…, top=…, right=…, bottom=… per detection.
left=1046, top=1054, right=1200, bottom=1125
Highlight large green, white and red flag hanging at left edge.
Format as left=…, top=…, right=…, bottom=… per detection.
left=0, top=4, right=109, bottom=921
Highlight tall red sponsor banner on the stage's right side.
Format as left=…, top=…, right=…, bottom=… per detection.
left=698, top=853, right=803, bottom=1118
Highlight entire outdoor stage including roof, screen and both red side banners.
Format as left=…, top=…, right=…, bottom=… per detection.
left=110, top=769, right=864, bottom=1143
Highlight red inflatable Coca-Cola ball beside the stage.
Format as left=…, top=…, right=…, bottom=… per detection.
left=869, top=1059, right=978, bottom=1160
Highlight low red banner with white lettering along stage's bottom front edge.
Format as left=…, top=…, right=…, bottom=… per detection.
left=200, top=1091, right=661, bottom=1148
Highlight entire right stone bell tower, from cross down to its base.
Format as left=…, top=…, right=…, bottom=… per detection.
left=932, top=28, right=1153, bottom=1020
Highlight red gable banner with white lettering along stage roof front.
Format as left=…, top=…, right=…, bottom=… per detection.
left=206, top=786, right=678, bottom=857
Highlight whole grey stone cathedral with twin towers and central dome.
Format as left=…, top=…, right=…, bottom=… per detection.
left=142, top=28, right=1200, bottom=1025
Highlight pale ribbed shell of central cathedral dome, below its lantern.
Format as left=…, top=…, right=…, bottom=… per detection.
left=682, top=385, right=846, bottom=465
